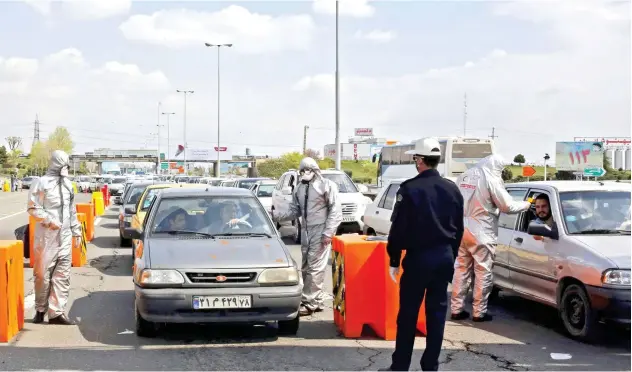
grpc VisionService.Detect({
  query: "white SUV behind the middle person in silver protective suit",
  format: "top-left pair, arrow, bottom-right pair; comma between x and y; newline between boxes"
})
272,169 -> 372,244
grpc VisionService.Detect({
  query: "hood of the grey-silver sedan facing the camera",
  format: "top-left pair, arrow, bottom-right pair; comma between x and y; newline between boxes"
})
148,237 -> 291,269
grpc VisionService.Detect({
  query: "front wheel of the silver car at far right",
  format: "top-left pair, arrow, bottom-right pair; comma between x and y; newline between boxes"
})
558,284 -> 599,342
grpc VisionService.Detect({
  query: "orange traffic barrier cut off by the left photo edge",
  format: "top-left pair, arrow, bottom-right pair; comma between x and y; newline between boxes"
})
0,240 -> 24,342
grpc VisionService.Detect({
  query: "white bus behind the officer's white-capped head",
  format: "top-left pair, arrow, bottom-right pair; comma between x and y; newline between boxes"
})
377,137 -> 496,187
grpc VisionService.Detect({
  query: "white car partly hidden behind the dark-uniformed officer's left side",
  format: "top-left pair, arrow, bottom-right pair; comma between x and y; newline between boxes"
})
362,178 -> 406,235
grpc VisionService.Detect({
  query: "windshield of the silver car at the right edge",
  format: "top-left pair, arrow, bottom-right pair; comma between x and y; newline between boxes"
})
560,191 -> 630,234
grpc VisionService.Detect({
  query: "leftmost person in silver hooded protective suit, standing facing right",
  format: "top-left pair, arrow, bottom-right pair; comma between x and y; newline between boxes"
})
28,150 -> 82,325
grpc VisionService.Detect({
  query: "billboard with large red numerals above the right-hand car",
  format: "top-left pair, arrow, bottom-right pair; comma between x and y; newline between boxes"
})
555,142 -> 604,172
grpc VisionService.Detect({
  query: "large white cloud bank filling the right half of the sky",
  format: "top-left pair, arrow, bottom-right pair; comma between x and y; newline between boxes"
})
293,1 -> 631,163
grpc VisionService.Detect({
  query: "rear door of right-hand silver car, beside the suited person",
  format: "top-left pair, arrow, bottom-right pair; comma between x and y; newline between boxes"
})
493,187 -> 528,289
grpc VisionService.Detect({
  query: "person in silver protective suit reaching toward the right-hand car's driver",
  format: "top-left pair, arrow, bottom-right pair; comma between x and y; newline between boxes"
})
451,154 -> 531,322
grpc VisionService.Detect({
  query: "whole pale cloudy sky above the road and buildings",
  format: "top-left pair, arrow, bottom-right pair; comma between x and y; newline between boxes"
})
0,0 -> 631,162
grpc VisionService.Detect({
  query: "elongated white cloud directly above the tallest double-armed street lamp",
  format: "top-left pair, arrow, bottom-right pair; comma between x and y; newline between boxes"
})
119,5 -> 315,54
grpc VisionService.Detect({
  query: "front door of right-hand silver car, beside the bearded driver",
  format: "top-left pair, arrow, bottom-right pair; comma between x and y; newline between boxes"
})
508,188 -> 559,304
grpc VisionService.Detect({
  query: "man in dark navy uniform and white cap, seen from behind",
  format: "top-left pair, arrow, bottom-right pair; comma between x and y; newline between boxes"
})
386,138 -> 463,371
